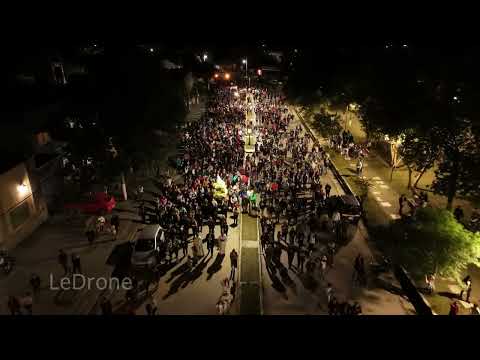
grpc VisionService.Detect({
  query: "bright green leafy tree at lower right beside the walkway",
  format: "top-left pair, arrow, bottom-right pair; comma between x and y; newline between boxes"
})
376,207 -> 480,279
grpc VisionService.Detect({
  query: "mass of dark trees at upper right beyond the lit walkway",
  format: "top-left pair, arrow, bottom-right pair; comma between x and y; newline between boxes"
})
286,43 -> 480,209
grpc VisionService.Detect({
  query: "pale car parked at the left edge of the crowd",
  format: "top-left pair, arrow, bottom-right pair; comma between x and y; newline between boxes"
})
131,225 -> 165,268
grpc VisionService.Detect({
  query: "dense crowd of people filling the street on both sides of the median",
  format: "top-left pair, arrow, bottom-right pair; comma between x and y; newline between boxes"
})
127,84 -> 364,313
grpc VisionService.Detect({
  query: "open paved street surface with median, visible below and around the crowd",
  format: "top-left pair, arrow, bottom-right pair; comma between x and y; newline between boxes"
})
0,90 -> 411,315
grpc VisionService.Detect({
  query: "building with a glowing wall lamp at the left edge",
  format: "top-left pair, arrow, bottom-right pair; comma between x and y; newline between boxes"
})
0,157 -> 48,249
